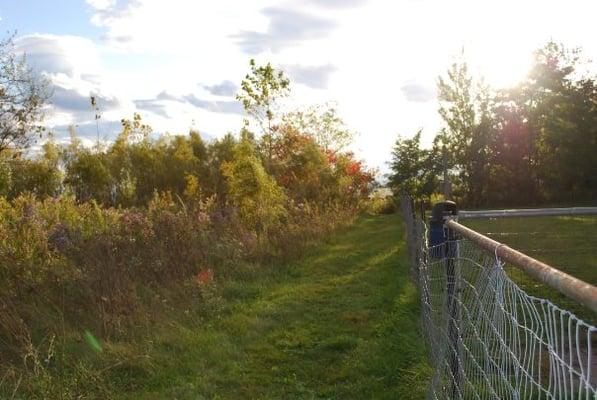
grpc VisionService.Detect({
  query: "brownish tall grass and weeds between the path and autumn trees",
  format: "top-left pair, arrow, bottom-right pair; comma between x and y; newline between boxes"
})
0,194 -> 356,398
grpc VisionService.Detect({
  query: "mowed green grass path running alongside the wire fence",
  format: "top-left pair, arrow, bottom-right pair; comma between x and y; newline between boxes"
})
121,215 -> 431,399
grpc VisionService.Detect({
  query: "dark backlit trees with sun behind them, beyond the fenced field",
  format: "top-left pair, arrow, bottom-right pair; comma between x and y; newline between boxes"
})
389,42 -> 597,207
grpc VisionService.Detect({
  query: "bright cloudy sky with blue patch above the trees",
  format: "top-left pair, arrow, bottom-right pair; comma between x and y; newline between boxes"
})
0,0 -> 597,172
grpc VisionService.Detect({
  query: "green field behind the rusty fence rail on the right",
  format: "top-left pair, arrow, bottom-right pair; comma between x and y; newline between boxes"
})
462,216 -> 597,323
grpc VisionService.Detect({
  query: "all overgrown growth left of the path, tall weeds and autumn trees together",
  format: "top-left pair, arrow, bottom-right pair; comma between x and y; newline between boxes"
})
0,53 -> 373,398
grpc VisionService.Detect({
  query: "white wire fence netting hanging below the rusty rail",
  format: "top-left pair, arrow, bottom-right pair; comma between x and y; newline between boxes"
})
407,211 -> 597,399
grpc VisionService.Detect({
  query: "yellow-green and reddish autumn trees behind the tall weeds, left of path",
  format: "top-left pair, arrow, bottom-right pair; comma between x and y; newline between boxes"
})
0,35 -> 373,223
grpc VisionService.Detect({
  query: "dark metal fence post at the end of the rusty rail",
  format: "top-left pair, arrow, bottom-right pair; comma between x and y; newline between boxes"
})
430,201 -> 462,399
